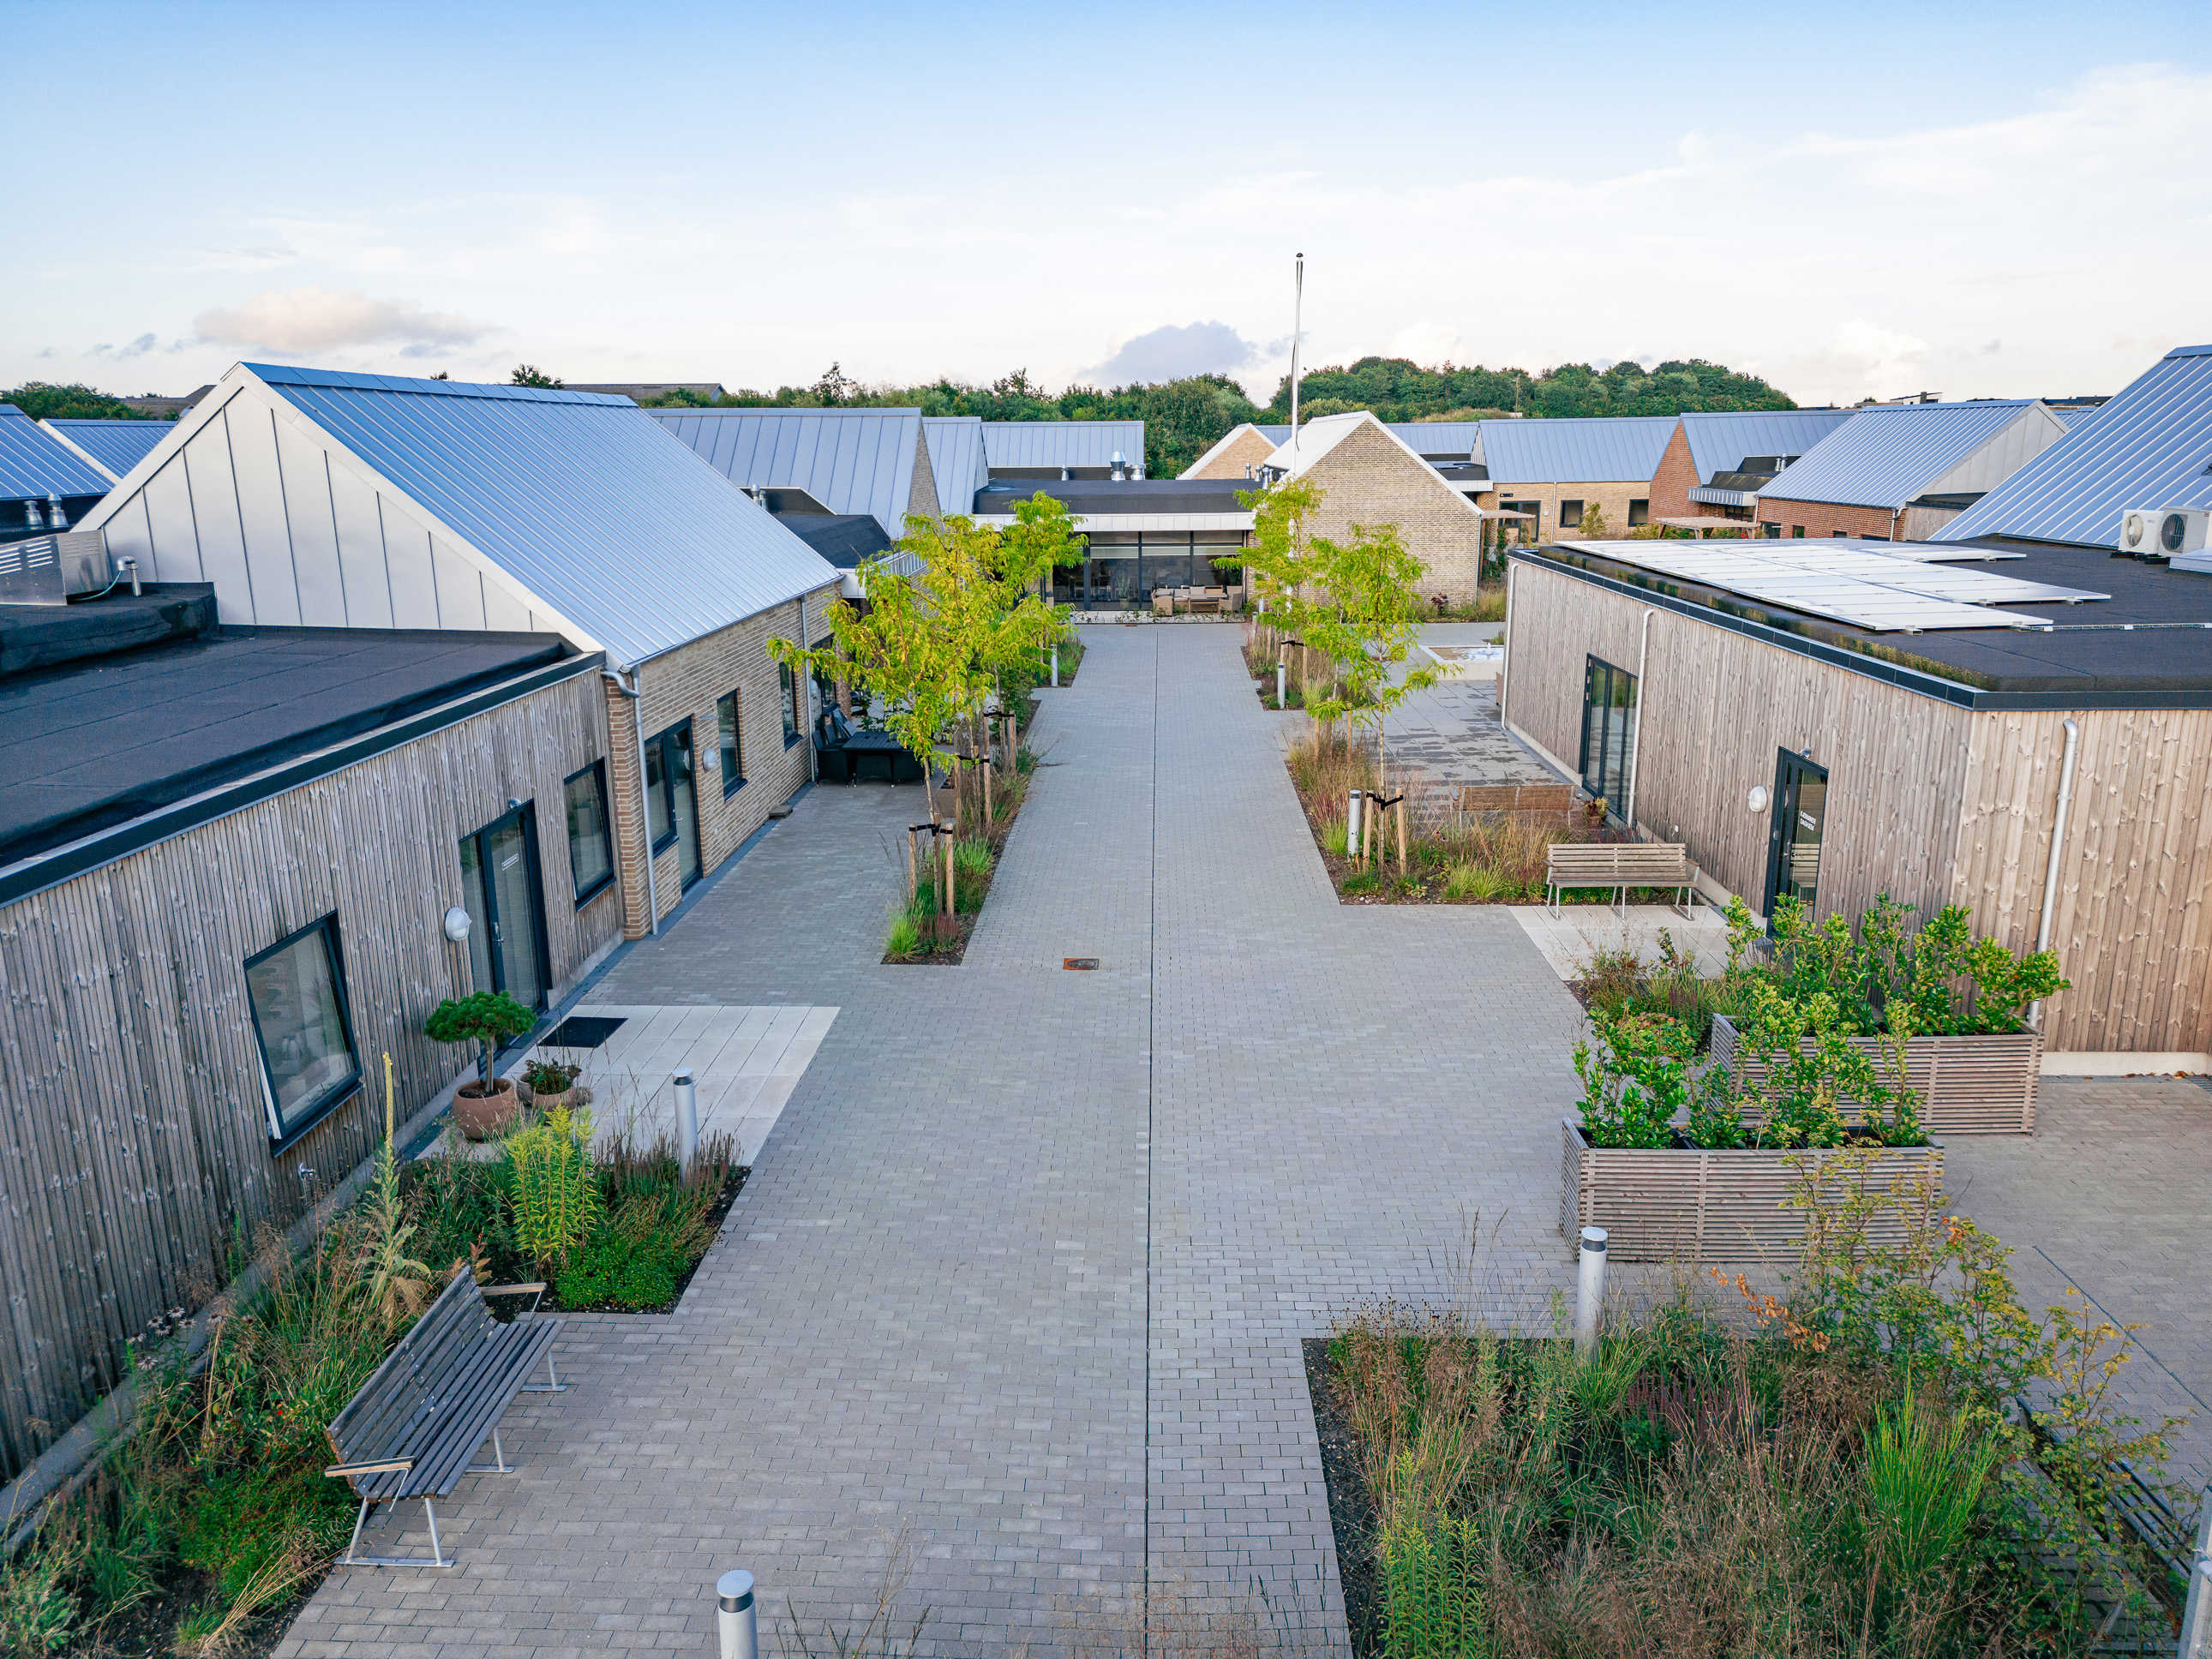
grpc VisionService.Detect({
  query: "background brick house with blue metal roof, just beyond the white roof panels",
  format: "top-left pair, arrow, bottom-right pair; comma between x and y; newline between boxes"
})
1754,398 -> 2066,542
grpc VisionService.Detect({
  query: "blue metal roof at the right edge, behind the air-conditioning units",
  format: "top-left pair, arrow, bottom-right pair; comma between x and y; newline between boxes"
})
1933,345 -> 2212,547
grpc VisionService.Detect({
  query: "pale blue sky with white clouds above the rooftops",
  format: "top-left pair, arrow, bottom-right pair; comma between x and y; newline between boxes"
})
0,0 -> 2212,404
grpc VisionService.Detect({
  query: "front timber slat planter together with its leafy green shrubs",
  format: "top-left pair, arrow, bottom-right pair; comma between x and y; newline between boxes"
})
1560,985 -> 1942,1263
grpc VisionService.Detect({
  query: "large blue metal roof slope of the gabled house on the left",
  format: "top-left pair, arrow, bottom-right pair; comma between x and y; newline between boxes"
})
243,362 -> 838,666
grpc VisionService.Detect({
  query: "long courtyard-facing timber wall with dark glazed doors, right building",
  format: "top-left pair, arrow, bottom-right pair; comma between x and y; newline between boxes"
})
1507,564 -> 1969,916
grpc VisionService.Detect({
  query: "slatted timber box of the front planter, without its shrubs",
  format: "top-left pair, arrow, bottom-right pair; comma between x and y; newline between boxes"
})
1560,1117 -> 1942,1266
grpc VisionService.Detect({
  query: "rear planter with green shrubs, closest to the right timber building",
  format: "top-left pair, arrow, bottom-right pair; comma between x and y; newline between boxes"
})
1712,894 -> 2066,1135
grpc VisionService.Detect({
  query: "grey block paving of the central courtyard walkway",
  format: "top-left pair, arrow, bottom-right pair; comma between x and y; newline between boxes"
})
279,628 -> 2212,1659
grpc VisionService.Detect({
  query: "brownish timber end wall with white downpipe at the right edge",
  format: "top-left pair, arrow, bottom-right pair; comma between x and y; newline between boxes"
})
1953,708 -> 2212,1053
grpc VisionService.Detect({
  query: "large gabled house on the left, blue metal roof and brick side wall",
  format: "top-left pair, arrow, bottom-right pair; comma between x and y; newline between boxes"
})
84,362 -> 841,937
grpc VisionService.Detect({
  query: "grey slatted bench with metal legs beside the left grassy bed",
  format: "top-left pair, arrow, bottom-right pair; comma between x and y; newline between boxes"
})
323,1267 -> 566,1566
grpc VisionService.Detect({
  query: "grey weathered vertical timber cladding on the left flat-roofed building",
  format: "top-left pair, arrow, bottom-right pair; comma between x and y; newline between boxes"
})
0,674 -> 621,1476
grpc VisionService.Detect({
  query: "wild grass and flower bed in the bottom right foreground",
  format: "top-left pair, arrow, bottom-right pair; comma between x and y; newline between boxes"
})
1316,1183 -> 2185,1659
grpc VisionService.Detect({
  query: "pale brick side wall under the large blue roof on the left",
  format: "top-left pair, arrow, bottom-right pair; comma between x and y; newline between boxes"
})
606,586 -> 836,937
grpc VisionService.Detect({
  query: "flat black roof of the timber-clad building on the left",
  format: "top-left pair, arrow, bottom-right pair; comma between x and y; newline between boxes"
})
0,628 -> 572,876
